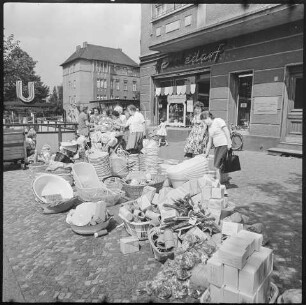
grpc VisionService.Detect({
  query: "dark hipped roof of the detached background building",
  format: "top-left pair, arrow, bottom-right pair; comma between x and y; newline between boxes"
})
60,44 -> 139,67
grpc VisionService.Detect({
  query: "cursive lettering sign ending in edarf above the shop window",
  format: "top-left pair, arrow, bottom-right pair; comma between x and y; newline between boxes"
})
155,43 -> 225,73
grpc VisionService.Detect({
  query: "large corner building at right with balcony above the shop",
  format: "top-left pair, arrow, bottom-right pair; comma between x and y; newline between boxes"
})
140,4 -> 304,149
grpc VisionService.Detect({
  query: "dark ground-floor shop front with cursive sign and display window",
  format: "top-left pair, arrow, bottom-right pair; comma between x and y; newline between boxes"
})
151,20 -> 303,149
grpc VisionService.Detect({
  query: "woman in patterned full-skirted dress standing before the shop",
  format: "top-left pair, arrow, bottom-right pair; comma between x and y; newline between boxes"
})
184,102 -> 207,158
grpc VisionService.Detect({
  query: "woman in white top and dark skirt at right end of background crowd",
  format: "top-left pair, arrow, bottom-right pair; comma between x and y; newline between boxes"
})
125,105 -> 145,153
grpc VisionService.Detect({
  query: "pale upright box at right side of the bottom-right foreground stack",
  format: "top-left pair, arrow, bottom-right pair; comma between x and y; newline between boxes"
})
239,252 -> 265,295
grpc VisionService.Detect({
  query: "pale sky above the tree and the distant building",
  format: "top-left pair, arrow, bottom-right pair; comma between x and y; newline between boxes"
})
3,3 -> 140,92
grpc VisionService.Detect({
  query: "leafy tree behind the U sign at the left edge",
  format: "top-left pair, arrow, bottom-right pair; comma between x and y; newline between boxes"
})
3,34 -> 49,102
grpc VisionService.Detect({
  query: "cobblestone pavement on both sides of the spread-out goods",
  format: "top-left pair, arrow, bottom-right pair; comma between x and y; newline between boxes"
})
3,143 -> 302,302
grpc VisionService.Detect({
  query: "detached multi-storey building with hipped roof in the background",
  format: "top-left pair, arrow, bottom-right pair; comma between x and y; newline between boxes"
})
61,42 -> 140,120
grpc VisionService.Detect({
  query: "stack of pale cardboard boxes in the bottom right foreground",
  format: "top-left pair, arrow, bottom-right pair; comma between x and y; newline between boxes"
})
207,230 -> 273,303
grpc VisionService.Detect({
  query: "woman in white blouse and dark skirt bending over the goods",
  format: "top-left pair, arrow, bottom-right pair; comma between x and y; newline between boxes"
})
200,111 -> 232,182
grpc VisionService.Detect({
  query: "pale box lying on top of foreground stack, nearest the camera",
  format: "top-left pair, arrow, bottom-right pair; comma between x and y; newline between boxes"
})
217,244 -> 247,268
